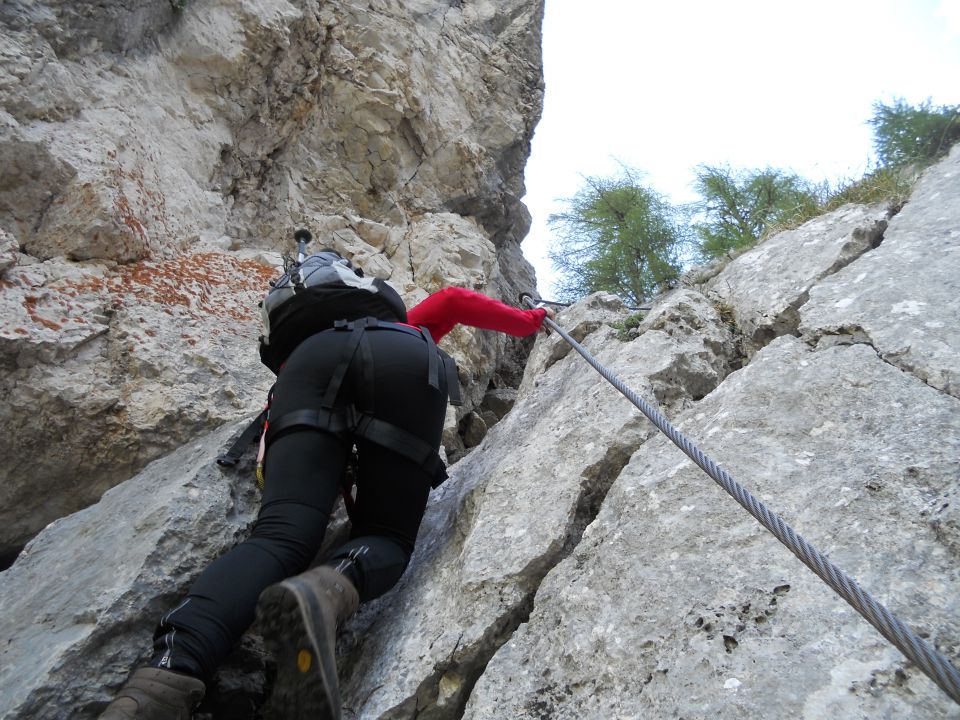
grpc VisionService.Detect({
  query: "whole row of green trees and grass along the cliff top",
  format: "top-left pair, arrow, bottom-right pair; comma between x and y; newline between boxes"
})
550,99 -> 960,305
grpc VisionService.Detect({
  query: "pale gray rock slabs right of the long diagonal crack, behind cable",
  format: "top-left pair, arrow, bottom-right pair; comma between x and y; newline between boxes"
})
458,147 -> 960,718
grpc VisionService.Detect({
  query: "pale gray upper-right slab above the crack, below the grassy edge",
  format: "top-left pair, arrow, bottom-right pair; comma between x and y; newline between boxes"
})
800,147 -> 960,397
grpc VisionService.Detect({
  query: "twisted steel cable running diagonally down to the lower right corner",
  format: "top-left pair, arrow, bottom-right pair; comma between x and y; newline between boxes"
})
520,293 -> 960,704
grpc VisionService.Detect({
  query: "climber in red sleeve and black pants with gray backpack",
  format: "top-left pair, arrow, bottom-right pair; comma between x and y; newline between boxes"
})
100,243 -> 553,720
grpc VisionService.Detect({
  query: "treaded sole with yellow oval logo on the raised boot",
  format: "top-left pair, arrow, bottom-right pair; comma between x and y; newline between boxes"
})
257,578 -> 340,720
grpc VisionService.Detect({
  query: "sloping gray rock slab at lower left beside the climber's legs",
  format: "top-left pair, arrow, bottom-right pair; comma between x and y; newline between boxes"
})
0,424 -> 259,720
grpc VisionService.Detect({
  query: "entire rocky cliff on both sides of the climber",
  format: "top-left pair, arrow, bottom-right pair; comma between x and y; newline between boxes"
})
0,0 -> 960,720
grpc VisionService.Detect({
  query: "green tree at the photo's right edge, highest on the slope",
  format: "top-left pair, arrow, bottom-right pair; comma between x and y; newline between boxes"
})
867,98 -> 960,168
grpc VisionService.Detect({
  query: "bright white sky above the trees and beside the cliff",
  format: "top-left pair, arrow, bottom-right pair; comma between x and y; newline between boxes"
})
522,0 -> 960,298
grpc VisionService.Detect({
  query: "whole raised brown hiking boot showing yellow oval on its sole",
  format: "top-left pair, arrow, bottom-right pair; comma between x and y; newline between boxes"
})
257,565 -> 360,720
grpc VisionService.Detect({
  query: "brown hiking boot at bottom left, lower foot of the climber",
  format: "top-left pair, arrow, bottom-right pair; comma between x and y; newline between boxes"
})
99,668 -> 206,720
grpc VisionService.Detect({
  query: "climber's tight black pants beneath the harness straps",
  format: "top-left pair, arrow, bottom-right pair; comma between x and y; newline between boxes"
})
152,329 -> 446,679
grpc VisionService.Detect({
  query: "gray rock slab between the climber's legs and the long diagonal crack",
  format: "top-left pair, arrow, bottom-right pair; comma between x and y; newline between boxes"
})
342,288 -> 732,718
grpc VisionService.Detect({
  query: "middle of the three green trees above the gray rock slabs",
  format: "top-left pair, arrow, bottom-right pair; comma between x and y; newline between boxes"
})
693,165 -> 821,260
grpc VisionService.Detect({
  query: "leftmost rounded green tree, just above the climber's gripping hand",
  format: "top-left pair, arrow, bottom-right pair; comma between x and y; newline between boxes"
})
549,168 -> 688,305
